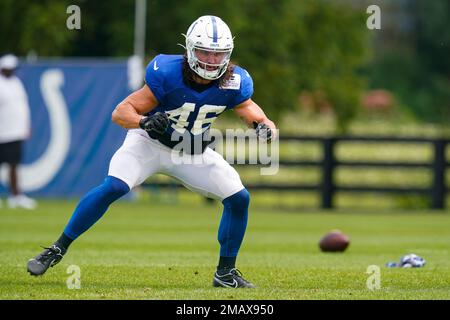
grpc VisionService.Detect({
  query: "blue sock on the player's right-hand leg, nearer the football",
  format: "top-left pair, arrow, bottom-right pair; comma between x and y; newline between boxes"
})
218,189 -> 250,260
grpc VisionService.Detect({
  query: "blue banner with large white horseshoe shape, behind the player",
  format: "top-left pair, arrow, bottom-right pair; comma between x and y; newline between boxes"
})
1,60 -> 130,197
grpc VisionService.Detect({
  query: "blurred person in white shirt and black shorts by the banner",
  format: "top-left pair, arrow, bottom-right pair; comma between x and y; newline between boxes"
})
0,54 -> 36,209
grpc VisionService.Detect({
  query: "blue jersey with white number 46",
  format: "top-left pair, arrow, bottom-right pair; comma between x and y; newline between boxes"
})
145,54 -> 253,153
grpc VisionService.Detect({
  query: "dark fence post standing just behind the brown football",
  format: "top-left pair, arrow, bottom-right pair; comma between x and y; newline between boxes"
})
322,138 -> 336,209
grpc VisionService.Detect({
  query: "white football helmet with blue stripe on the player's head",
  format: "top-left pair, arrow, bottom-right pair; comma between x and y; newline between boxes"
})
184,16 -> 234,80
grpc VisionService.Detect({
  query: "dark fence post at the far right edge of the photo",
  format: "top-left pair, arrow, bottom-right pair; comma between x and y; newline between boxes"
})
431,140 -> 447,209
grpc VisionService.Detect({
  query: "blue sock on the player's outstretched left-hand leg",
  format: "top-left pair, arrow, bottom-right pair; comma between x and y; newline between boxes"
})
64,176 -> 130,240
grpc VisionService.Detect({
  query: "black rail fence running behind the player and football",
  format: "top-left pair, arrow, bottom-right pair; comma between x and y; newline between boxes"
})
142,136 -> 450,209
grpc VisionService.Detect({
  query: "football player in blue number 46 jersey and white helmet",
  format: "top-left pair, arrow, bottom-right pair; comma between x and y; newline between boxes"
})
28,16 -> 276,288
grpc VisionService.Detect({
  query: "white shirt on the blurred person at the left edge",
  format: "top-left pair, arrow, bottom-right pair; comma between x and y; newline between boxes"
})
0,74 -> 31,143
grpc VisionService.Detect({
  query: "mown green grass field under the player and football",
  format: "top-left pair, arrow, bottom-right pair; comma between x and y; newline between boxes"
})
0,200 -> 450,300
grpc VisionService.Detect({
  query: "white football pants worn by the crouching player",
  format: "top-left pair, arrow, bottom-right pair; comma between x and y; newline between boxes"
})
108,129 -> 244,200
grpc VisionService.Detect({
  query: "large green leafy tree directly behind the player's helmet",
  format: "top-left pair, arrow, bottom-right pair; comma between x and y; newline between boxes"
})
147,0 -> 368,130
